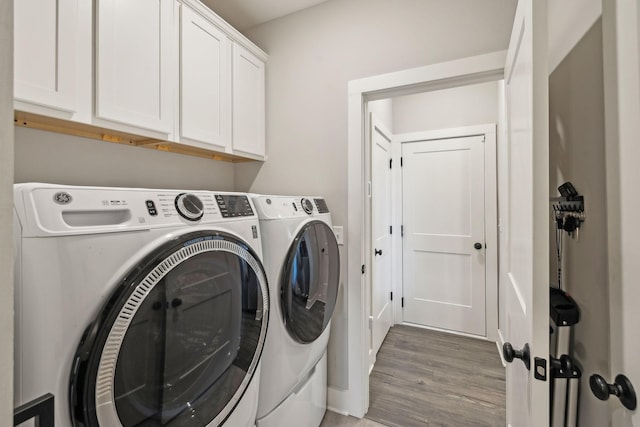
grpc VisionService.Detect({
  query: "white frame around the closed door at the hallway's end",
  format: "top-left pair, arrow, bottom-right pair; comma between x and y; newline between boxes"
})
391,123 -> 498,342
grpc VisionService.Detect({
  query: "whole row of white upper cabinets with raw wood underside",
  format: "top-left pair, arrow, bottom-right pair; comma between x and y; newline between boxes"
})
13,0 -> 267,160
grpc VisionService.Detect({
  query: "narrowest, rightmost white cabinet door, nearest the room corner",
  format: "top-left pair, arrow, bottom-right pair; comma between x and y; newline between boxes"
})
232,44 -> 265,158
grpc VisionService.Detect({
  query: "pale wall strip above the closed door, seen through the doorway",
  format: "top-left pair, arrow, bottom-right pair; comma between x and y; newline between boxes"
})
393,81 -> 498,134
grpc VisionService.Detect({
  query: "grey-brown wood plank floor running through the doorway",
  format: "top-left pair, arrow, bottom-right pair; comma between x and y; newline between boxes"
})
322,325 -> 505,427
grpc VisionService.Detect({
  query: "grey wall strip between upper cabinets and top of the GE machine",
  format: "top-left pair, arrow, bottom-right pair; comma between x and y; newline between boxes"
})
15,128 -> 234,190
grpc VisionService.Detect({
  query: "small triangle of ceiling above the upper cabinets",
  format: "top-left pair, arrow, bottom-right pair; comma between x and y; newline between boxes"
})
202,0 -> 327,31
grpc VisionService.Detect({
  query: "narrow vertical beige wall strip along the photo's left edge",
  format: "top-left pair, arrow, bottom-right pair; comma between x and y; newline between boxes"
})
0,0 -> 13,426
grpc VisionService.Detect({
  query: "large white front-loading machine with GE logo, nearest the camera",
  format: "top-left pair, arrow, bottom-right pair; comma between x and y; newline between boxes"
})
14,184 -> 269,427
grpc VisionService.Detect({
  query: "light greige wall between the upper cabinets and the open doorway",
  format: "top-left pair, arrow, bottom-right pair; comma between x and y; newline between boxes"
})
235,0 -> 516,396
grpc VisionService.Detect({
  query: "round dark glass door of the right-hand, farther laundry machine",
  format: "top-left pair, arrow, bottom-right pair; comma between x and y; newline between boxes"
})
281,221 -> 340,344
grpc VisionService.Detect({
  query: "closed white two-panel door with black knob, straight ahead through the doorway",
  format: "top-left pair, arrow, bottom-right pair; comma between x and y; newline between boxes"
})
402,135 -> 486,336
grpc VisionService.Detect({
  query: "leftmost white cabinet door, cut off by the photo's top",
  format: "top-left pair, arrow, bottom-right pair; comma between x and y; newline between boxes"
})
14,0 -> 77,113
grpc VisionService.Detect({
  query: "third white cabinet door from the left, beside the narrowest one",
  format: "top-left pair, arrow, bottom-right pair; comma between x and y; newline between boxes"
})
180,5 -> 231,149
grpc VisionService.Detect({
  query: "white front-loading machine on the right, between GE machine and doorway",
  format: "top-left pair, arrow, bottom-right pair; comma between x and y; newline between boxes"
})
253,195 -> 340,427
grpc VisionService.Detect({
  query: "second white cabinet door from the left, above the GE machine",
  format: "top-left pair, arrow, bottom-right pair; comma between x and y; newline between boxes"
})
96,0 -> 174,133
